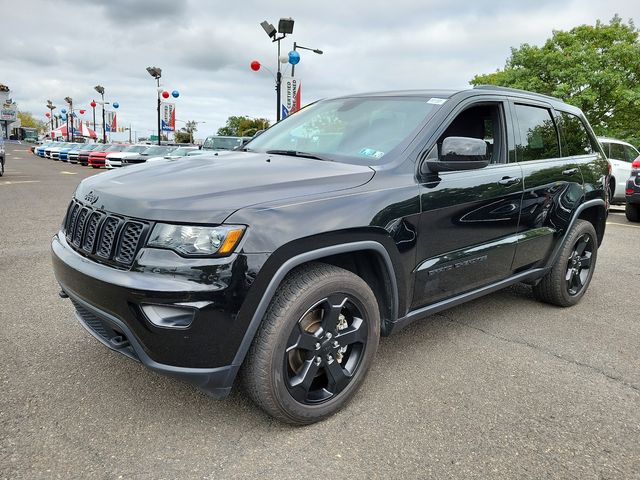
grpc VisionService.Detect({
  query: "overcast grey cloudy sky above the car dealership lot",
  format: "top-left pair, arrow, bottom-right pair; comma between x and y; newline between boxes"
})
0,0 -> 640,137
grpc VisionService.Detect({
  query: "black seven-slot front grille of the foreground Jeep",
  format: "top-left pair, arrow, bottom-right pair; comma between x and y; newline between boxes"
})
64,200 -> 149,266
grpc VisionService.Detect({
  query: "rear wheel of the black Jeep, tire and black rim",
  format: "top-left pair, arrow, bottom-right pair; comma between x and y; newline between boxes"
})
533,220 -> 598,307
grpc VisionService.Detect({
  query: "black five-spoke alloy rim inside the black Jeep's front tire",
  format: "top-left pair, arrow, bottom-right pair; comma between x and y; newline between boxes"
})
283,293 -> 367,404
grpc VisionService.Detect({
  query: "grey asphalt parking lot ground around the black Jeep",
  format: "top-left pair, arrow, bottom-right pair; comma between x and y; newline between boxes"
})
0,145 -> 640,479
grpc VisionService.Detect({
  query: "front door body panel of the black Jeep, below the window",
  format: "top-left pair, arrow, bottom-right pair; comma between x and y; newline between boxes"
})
412,164 -> 523,308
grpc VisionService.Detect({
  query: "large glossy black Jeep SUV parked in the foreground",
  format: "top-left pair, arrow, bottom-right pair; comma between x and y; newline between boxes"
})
52,87 -> 609,424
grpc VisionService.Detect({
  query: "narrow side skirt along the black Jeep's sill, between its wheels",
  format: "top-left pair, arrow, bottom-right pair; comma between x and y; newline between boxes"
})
389,267 -> 549,333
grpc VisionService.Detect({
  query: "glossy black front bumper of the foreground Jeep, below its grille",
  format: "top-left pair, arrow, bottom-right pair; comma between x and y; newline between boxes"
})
51,234 -> 264,397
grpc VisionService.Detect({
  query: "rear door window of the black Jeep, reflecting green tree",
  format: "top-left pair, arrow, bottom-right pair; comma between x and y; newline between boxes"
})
515,104 -> 560,162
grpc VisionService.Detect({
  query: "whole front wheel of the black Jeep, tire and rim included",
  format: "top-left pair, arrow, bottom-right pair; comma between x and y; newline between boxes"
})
243,263 -> 380,425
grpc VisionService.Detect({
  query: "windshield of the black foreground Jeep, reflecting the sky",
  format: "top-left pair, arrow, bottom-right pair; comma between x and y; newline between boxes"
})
246,97 -> 437,165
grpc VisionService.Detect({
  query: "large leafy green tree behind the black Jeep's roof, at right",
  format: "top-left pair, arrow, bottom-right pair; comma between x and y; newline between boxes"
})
470,15 -> 640,145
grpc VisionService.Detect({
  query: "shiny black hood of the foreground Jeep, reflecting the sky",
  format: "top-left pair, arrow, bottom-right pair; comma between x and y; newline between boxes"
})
75,152 -> 375,223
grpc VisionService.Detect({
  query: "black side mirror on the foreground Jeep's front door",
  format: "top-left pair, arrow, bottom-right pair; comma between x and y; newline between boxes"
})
423,137 -> 489,173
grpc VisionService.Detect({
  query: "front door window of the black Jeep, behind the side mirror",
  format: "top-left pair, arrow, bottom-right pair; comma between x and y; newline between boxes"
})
438,103 -> 501,164
